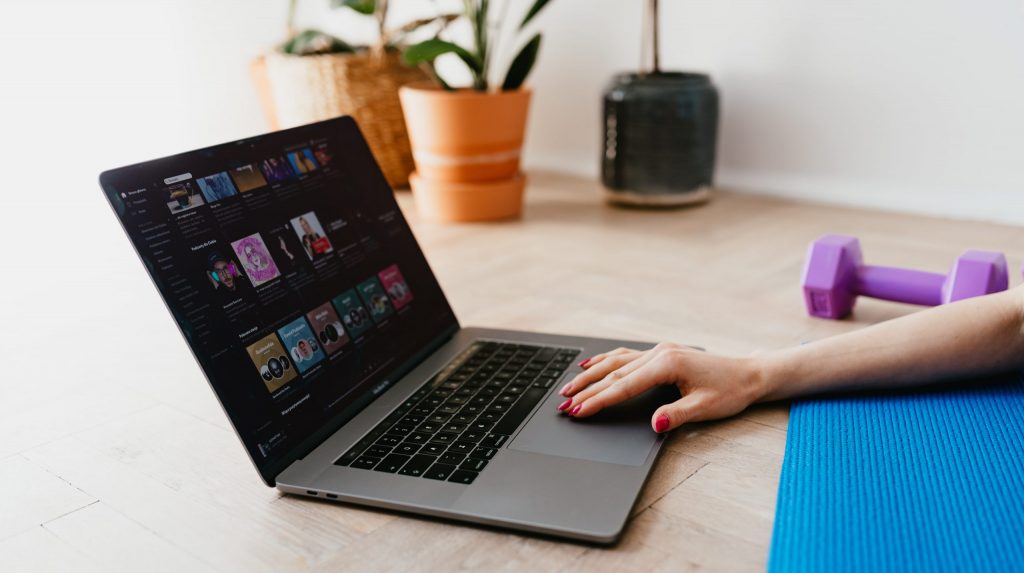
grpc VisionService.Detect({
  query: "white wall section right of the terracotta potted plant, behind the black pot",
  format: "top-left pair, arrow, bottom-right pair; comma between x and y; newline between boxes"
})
516,0 -> 1024,223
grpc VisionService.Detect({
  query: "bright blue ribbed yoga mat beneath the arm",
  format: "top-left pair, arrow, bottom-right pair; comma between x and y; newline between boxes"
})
768,376 -> 1024,572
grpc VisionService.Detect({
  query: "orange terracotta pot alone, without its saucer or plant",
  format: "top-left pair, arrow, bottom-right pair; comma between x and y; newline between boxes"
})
398,84 -> 530,183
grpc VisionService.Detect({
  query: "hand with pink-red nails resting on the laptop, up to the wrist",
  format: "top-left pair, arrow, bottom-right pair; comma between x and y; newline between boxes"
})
558,343 -> 765,432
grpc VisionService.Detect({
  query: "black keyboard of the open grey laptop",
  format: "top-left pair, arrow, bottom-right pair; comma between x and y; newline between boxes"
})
335,341 -> 580,484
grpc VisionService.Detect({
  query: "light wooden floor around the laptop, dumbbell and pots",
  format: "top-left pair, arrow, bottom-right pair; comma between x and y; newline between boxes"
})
0,174 -> 1024,573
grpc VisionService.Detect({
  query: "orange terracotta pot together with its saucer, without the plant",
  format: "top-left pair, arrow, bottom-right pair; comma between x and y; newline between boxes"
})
398,84 -> 530,222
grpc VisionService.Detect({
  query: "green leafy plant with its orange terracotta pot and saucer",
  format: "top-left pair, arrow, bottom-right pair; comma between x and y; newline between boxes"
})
399,0 -> 549,221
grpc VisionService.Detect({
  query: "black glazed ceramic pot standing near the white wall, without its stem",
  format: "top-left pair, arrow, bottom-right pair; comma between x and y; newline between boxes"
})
601,72 -> 719,207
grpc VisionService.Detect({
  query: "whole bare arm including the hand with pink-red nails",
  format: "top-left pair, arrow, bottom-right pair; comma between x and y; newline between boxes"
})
560,287 -> 1024,432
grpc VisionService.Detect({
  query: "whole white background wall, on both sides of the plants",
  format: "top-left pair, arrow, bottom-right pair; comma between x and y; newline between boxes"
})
0,0 -> 1024,223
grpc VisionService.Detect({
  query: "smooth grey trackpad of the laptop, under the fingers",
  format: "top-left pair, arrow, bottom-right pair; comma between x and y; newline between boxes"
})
509,386 -> 679,466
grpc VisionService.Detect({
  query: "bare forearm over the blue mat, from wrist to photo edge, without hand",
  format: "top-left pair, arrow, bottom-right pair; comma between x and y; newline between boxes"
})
753,287 -> 1024,401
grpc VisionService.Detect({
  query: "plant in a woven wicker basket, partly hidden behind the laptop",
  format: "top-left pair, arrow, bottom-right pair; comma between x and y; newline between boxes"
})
252,0 -> 457,188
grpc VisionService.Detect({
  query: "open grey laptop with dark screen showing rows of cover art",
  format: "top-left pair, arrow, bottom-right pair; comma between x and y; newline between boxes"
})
99,117 -> 679,543
